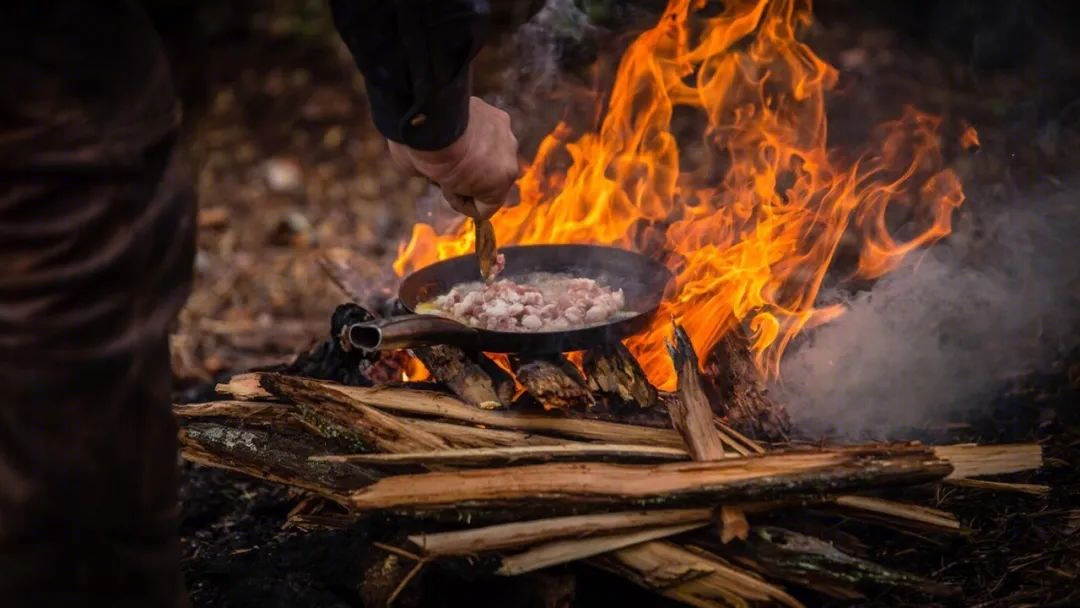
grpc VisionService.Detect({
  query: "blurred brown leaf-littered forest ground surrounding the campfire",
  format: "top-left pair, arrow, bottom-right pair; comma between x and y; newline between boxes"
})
172,1 -> 1080,608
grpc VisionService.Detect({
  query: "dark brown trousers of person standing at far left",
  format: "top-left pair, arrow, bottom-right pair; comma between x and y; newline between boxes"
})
0,0 -> 194,608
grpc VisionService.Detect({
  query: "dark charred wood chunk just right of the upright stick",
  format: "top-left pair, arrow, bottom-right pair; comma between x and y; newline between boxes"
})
703,329 -> 791,441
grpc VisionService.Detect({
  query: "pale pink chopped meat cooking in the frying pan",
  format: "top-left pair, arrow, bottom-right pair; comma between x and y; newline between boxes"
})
422,272 -> 625,332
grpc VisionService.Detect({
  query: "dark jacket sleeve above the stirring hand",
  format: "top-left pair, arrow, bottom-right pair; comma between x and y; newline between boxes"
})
330,0 -> 489,150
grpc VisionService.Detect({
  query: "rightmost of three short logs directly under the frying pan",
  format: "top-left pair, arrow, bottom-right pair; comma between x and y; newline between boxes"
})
582,341 -> 658,409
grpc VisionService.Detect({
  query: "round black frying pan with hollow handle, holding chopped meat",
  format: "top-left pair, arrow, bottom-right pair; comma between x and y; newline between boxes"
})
342,245 -> 672,354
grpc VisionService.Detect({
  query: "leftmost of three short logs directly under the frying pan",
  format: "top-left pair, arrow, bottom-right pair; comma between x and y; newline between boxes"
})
413,344 -> 514,409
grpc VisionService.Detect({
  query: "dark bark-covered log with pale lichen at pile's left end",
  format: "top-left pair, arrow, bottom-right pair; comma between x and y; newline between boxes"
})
180,422 -> 377,504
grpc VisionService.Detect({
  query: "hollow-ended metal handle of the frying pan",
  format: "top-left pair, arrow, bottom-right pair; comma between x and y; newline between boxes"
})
342,314 -> 477,351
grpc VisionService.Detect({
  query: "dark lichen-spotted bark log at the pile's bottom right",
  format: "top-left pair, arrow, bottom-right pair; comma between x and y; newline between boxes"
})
740,526 -> 958,598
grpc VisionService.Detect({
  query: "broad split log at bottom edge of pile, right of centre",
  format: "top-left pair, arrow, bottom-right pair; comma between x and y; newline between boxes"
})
589,541 -> 802,608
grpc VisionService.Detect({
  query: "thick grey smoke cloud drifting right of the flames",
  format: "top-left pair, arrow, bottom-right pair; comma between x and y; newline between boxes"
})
775,187 -> 1080,440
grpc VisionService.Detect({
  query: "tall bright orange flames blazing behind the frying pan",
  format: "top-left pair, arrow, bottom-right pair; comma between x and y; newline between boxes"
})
395,0 -> 973,388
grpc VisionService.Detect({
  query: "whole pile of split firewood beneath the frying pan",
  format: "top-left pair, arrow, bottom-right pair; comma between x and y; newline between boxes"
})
174,327 -> 1042,608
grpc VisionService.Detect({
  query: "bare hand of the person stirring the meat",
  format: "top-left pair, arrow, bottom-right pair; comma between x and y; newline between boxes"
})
389,97 -> 518,219
